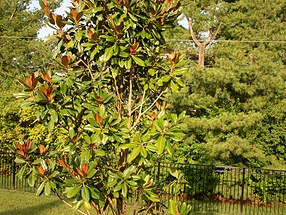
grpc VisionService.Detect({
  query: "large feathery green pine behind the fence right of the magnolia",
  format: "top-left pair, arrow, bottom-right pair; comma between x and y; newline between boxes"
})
170,0 -> 286,167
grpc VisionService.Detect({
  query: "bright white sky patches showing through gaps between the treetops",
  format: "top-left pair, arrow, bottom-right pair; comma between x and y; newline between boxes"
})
31,0 -> 188,39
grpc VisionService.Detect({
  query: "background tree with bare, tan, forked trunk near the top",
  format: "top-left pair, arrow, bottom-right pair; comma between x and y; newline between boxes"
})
182,0 -> 225,67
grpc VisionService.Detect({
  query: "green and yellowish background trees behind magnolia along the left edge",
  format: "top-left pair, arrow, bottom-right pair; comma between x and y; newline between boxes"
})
0,0 -> 61,150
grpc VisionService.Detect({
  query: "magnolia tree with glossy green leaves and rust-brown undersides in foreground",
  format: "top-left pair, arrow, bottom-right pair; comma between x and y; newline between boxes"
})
15,0 -> 185,215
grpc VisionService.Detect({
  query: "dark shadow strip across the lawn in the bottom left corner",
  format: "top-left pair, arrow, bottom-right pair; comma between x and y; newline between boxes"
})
0,200 -> 62,215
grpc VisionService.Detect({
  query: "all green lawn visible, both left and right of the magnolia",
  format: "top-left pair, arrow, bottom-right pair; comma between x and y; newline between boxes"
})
0,189 -> 286,215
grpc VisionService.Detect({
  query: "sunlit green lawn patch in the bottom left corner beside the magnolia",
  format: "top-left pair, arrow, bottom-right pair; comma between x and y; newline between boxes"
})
0,189 -> 78,215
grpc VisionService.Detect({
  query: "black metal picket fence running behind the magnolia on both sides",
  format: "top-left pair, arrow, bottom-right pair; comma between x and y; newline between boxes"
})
0,153 -> 286,215
